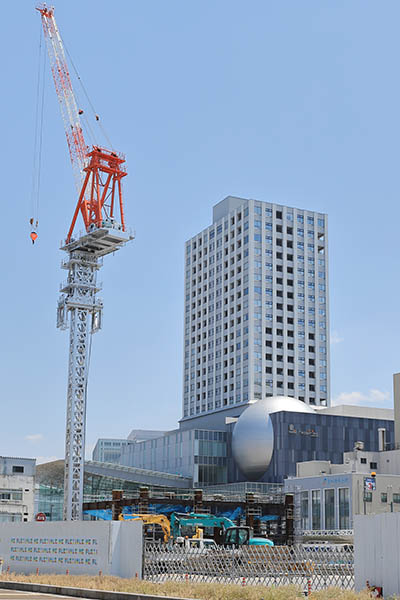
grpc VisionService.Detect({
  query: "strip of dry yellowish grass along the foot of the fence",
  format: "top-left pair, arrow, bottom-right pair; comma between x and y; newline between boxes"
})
0,573 -> 371,600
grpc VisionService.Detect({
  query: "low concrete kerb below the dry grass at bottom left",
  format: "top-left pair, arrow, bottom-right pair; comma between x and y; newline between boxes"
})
0,581 -> 190,600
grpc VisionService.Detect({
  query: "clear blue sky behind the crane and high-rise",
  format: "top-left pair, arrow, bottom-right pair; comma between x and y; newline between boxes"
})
0,0 -> 400,459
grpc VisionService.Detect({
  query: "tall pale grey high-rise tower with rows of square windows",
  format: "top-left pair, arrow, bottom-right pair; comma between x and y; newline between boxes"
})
183,196 -> 329,421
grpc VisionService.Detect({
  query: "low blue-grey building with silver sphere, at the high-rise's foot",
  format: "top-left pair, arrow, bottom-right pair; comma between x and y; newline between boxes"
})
121,396 -> 394,487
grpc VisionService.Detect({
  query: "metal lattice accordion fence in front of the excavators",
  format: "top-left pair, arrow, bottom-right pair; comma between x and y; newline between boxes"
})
143,540 -> 354,590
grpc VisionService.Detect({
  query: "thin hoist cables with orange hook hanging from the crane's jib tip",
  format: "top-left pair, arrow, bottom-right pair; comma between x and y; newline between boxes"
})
29,22 -> 46,244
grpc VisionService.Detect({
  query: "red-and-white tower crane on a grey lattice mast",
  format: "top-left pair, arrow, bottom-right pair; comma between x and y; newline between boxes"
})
37,4 -> 133,520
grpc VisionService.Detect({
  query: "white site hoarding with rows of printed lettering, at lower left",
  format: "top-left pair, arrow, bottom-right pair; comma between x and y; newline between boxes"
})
0,521 -> 143,577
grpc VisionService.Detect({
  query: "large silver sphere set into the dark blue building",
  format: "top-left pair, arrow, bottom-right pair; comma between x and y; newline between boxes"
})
232,396 -> 315,481
